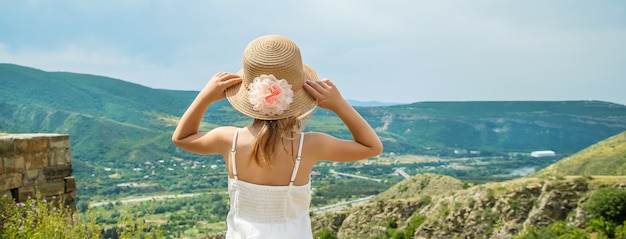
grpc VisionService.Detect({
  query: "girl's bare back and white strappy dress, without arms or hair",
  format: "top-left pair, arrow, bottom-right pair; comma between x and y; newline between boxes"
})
226,129 -> 312,238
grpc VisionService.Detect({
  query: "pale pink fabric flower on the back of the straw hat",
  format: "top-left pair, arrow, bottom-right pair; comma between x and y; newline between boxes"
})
248,75 -> 293,116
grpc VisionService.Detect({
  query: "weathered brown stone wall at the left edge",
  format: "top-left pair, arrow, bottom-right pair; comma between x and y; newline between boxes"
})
0,134 -> 76,205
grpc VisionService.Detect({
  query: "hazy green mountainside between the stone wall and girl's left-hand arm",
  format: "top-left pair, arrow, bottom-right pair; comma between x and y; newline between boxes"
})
0,64 -> 201,162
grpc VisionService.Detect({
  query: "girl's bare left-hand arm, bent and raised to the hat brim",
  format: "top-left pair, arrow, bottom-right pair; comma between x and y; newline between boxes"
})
172,72 -> 242,154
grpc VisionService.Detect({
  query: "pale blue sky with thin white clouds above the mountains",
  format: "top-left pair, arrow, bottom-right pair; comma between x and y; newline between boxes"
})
0,0 -> 626,105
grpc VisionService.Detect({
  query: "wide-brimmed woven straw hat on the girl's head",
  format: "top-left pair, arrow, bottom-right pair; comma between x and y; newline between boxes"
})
226,35 -> 319,120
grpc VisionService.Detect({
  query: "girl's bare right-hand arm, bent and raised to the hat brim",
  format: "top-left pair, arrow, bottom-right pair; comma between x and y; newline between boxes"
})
304,79 -> 383,162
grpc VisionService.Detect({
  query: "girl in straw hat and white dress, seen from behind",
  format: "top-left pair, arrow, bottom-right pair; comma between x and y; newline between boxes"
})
172,35 -> 383,238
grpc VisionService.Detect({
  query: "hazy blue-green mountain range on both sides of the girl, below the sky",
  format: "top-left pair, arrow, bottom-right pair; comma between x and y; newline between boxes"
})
0,64 -> 626,162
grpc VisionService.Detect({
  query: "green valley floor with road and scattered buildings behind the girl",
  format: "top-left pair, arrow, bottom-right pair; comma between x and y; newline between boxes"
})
75,150 -> 562,236
